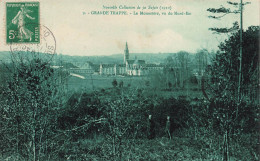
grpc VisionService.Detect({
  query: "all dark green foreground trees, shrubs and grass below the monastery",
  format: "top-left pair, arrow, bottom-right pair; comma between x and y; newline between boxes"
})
0,27 -> 259,161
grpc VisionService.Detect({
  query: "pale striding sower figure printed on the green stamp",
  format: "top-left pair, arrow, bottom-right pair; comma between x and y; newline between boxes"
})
12,5 -> 35,41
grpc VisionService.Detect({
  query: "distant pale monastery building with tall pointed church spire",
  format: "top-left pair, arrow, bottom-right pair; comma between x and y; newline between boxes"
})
99,43 -> 164,76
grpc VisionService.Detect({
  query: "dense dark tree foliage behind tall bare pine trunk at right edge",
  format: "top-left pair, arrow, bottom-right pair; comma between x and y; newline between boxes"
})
211,26 -> 259,98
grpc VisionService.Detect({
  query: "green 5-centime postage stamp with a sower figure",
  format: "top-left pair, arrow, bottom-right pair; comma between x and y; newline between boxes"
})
6,2 -> 40,43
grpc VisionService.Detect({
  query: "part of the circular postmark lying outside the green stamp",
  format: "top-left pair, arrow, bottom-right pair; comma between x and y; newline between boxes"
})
10,23 -> 56,63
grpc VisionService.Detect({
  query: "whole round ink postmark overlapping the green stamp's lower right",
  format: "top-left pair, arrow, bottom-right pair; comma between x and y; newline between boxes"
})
10,23 -> 56,63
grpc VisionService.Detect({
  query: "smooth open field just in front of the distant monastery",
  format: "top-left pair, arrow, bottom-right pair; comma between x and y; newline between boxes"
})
68,75 -> 203,98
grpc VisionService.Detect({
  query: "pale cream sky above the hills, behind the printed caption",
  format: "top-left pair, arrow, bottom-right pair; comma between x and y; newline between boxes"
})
0,0 -> 260,56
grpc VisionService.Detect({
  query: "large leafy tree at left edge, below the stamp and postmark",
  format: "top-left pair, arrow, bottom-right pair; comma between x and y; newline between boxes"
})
0,59 -> 65,160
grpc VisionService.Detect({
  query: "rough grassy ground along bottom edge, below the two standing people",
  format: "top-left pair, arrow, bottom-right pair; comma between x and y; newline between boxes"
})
51,131 -> 258,161
